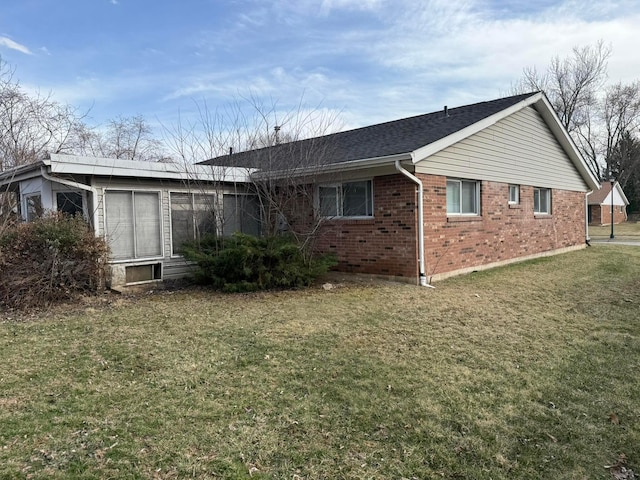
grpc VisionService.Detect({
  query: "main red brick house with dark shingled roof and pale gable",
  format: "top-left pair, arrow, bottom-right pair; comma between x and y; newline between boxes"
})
203,92 -> 599,285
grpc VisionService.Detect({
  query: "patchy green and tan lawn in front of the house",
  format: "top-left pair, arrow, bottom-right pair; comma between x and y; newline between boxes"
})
0,246 -> 640,480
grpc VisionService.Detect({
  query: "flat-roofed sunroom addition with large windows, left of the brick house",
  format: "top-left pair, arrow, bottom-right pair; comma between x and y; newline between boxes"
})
0,155 -> 255,287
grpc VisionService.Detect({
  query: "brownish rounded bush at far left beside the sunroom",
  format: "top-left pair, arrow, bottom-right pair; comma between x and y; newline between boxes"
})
0,213 -> 108,308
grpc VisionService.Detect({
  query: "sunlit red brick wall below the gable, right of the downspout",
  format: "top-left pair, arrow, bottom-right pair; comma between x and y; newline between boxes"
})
420,175 -> 585,277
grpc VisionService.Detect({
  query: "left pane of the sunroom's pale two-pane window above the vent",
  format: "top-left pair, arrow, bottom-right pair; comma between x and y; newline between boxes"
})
105,192 -> 135,260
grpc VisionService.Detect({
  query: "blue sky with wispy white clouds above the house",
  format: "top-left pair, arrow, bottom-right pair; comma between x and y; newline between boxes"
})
0,0 -> 640,139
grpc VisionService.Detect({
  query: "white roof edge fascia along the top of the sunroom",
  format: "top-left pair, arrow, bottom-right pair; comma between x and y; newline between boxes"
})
47,155 -> 252,182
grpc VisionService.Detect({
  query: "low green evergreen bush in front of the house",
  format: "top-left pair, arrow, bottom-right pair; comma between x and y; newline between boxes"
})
183,233 -> 335,292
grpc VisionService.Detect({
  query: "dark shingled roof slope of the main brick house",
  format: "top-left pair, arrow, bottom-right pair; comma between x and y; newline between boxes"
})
201,92 -> 538,171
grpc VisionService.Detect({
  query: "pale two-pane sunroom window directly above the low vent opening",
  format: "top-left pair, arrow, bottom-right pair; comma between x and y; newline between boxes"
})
105,190 -> 162,260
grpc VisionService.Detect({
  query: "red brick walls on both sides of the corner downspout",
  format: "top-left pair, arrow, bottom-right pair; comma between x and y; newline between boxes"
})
317,175 -> 585,280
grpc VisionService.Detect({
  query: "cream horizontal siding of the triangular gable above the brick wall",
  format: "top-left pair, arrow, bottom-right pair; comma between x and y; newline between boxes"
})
416,107 -> 588,191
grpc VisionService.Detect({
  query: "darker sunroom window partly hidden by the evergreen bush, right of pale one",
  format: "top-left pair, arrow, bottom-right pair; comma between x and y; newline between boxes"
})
170,192 -> 217,255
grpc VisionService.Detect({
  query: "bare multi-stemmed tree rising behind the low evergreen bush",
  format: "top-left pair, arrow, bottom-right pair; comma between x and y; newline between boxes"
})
165,95 -> 344,260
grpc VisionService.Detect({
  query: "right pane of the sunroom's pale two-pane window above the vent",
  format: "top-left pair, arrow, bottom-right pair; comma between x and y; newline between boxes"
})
133,192 -> 162,257
